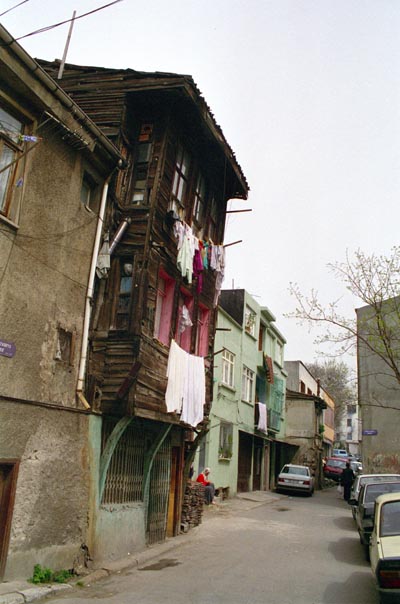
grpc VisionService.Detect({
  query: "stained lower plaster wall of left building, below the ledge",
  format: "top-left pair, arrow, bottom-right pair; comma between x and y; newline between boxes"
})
0,398 -> 89,580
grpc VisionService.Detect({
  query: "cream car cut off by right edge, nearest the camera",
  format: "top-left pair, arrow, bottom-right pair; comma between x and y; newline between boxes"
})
369,493 -> 400,604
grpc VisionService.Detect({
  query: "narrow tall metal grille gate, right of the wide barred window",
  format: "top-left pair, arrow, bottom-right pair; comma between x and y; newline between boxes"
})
147,437 -> 171,544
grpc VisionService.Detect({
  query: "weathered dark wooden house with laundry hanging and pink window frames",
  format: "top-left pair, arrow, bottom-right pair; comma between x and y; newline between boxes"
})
41,61 -> 248,558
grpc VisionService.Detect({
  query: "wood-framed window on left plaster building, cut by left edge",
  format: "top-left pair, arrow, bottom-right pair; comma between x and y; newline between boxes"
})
0,107 -> 24,216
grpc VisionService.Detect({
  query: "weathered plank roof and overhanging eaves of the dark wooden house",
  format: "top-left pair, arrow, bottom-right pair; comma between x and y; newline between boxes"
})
37,59 -> 249,199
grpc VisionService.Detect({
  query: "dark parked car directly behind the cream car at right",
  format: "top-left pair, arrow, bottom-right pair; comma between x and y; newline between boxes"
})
353,480 -> 400,560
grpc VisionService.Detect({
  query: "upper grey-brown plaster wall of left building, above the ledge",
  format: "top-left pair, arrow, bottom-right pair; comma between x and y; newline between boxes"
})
0,126 -> 101,405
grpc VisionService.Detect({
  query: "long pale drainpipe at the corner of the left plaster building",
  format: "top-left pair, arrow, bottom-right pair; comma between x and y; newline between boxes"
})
76,177 -> 110,409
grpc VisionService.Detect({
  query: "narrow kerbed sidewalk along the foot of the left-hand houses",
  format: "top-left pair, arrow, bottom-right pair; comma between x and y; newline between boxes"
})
0,491 -> 281,604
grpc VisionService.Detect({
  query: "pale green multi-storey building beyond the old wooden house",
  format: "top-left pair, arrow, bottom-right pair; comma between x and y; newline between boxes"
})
196,289 -> 286,495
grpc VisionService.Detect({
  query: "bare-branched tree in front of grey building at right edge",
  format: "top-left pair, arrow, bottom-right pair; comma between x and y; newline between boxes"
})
286,246 -> 400,410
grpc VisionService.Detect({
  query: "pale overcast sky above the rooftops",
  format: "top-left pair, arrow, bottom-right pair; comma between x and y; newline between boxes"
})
0,0 -> 400,362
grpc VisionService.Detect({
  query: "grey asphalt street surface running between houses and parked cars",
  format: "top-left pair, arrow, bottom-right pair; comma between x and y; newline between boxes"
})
46,488 -> 378,604
